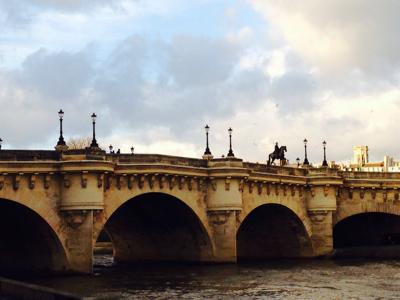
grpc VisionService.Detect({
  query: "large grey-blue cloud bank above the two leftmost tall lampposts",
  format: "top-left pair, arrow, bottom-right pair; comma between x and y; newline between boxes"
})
0,35 -> 268,150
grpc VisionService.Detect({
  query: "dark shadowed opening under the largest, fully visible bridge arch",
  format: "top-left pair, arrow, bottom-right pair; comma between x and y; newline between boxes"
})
103,193 -> 213,262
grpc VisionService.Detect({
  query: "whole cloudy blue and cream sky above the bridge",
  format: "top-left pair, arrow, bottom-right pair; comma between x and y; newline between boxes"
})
0,0 -> 400,163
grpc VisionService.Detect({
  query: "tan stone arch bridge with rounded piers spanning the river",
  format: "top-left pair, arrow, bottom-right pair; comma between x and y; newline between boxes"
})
0,148 -> 400,273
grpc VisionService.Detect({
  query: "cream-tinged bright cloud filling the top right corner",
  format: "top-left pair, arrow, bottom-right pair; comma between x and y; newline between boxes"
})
251,0 -> 400,80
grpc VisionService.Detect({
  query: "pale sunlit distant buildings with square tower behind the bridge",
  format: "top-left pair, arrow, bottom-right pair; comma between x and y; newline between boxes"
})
338,146 -> 400,172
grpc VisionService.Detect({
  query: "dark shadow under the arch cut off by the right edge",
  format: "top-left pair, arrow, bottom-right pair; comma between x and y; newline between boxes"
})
333,212 -> 400,250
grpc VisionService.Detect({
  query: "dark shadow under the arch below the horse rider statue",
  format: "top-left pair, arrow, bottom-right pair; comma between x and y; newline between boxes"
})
236,203 -> 313,261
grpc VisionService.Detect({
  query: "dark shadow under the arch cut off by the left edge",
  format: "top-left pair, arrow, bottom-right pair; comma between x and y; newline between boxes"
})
0,199 -> 68,275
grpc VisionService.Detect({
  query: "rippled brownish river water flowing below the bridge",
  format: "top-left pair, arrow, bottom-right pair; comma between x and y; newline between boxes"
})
21,255 -> 400,299
